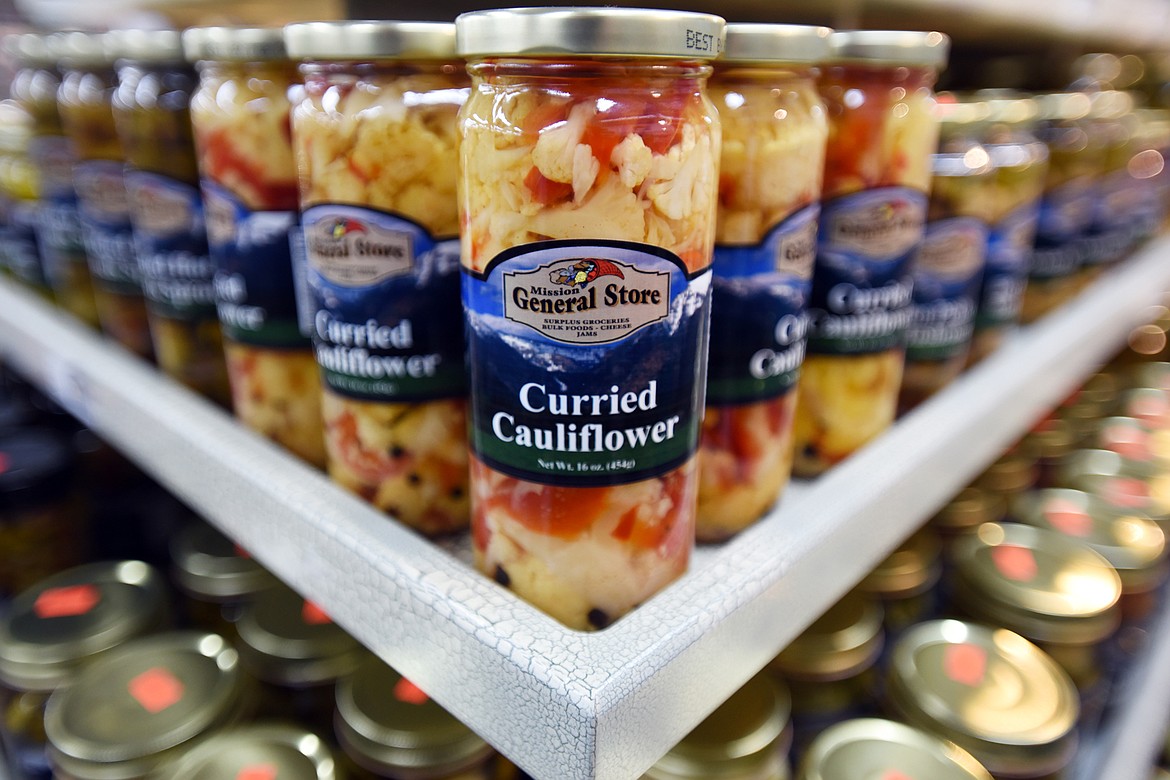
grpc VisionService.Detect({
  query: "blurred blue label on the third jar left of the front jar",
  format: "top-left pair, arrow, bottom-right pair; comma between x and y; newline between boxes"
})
125,170 -> 215,319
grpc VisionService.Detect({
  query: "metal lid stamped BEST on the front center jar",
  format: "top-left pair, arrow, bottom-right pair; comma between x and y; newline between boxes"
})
455,7 -> 725,60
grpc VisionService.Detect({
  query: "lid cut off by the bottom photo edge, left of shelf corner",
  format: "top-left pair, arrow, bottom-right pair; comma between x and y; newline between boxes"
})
151,723 -> 342,780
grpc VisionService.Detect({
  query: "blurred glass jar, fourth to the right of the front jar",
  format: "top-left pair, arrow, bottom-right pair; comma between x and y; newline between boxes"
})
969,90 -> 1048,364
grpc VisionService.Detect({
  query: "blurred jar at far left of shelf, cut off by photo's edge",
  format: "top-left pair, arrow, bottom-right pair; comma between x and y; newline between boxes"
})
0,95 -> 53,294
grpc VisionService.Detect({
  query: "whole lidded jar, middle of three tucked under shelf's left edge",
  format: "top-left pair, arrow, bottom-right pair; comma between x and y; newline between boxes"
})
235,584 -> 362,733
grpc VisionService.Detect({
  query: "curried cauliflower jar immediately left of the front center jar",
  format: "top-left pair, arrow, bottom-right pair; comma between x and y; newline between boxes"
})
285,22 -> 469,534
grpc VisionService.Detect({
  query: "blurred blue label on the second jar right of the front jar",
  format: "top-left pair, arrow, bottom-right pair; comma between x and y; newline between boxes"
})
808,187 -> 927,354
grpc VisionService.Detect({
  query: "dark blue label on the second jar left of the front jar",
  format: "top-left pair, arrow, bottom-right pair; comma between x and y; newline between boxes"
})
202,179 -> 308,347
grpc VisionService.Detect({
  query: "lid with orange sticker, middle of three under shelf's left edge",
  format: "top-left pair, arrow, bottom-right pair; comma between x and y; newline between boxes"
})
235,585 -> 363,686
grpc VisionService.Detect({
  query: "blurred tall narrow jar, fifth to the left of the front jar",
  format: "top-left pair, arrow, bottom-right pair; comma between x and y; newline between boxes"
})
6,33 -> 98,327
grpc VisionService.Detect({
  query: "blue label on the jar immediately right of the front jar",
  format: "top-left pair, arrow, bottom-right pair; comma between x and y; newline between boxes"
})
707,205 -> 820,405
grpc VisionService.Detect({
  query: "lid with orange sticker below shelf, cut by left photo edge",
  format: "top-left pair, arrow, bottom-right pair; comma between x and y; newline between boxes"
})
0,560 -> 167,691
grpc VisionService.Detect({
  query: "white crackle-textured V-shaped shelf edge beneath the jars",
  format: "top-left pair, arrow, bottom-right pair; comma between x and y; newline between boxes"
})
0,239 -> 1170,780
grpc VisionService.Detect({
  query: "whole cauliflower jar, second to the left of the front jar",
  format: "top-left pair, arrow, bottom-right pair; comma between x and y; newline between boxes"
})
183,27 -> 325,468
